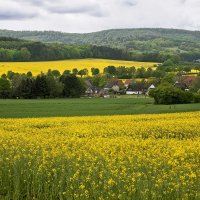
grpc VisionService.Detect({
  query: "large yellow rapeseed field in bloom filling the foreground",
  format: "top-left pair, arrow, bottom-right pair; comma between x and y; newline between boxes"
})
0,112 -> 200,200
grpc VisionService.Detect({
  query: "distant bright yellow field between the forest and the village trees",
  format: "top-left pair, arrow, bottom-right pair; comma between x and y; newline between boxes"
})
0,59 -> 157,75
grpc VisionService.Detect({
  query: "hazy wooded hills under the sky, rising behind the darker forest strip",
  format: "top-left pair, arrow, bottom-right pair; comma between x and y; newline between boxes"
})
0,29 -> 200,63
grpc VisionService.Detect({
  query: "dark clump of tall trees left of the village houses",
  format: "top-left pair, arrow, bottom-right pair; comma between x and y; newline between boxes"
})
0,70 -> 85,99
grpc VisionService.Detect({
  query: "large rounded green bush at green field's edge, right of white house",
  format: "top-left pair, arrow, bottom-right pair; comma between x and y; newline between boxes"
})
149,84 -> 193,104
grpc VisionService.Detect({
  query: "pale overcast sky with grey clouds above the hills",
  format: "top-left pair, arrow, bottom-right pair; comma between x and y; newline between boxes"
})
0,0 -> 200,32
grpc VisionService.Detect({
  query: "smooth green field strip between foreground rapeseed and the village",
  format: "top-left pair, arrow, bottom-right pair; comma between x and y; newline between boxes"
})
0,98 -> 200,118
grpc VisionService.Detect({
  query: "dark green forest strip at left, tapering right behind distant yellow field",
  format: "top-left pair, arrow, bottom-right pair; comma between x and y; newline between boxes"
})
0,37 -> 131,61
